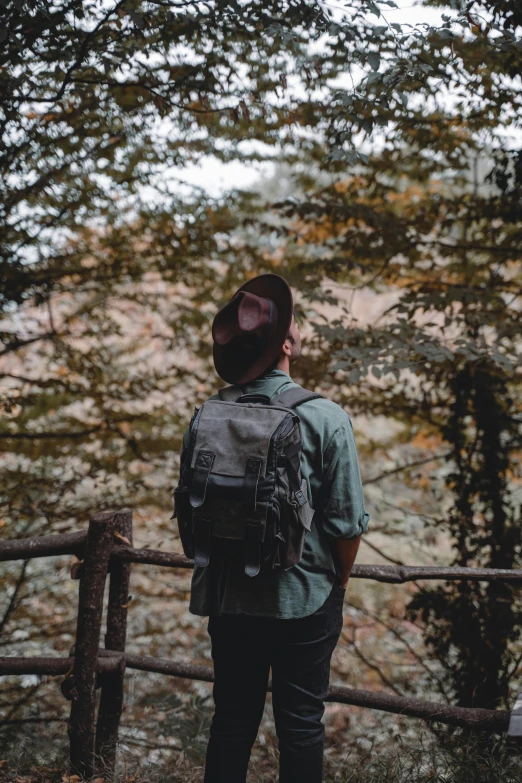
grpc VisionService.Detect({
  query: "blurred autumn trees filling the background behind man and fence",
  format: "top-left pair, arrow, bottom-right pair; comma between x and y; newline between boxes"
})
0,0 -> 522,776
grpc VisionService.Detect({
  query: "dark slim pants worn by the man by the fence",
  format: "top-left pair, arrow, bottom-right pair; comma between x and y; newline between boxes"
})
205,583 -> 345,783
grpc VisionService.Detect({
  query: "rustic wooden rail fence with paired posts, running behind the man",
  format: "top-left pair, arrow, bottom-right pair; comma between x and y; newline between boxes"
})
0,509 -> 522,777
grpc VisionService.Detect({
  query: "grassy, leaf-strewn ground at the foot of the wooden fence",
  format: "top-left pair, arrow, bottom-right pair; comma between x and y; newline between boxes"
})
0,710 -> 522,783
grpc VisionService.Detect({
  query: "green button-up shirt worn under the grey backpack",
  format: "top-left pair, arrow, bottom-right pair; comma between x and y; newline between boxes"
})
182,370 -> 370,618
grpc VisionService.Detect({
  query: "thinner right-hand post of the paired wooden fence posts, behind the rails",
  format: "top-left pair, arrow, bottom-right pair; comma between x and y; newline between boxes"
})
95,509 -> 132,773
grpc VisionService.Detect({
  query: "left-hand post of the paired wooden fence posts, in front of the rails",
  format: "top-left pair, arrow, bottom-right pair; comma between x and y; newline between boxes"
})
67,511 -> 117,777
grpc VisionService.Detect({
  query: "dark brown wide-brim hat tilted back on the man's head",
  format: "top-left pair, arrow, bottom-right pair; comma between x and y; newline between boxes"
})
212,274 -> 294,384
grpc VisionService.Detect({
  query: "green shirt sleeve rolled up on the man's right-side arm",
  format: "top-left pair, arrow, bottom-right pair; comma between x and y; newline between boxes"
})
322,414 -> 370,539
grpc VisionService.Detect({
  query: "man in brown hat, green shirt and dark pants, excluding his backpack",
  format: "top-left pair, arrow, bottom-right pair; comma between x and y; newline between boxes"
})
177,274 -> 369,783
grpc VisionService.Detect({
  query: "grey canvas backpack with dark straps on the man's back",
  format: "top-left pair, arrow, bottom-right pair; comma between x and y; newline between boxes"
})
172,386 -> 323,576
